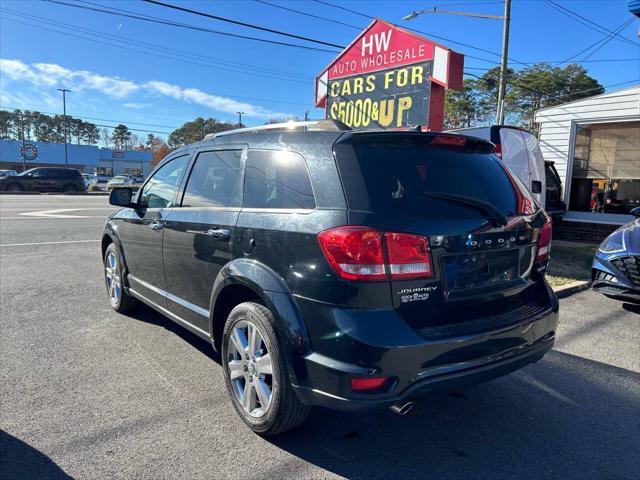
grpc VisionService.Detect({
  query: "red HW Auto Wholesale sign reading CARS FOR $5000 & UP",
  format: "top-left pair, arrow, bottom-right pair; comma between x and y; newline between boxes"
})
315,19 -> 464,130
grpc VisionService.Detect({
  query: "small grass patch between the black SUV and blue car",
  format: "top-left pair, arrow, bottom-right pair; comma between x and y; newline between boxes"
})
547,245 -> 598,287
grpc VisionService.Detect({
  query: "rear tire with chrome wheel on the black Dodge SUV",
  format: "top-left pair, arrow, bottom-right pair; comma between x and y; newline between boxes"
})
222,302 -> 310,436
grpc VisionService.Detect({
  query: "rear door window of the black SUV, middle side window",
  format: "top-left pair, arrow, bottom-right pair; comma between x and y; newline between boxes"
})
182,150 -> 242,207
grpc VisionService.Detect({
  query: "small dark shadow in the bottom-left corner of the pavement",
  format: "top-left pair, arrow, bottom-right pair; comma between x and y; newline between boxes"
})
0,430 -> 72,480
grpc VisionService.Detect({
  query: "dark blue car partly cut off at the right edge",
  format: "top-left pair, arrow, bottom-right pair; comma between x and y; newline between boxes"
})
591,207 -> 640,304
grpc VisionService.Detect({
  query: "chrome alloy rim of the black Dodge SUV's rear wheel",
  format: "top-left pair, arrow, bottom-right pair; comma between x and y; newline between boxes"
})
227,320 -> 276,418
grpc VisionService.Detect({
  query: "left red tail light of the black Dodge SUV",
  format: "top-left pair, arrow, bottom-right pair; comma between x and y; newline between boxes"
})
318,227 -> 433,280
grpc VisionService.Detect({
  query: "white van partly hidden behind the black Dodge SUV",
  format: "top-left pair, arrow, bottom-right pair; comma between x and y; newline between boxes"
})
451,125 -> 547,208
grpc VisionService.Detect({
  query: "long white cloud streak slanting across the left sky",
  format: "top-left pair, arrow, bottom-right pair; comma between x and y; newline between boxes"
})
0,59 -> 290,118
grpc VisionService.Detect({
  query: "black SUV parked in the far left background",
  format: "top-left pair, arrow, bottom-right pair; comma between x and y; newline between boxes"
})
0,167 -> 86,192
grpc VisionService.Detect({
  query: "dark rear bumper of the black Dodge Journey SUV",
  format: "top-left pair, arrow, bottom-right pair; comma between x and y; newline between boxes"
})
294,286 -> 558,411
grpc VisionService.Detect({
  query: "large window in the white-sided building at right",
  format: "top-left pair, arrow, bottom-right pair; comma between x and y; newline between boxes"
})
569,122 -> 640,214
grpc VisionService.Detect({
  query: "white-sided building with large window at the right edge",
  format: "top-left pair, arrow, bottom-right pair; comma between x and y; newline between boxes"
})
535,85 -> 640,241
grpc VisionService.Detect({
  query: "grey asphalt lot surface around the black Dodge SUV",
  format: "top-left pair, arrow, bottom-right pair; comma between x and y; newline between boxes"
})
0,195 -> 640,479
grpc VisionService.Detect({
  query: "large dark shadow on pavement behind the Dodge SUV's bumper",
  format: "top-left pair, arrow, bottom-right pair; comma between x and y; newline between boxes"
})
263,351 -> 640,479
